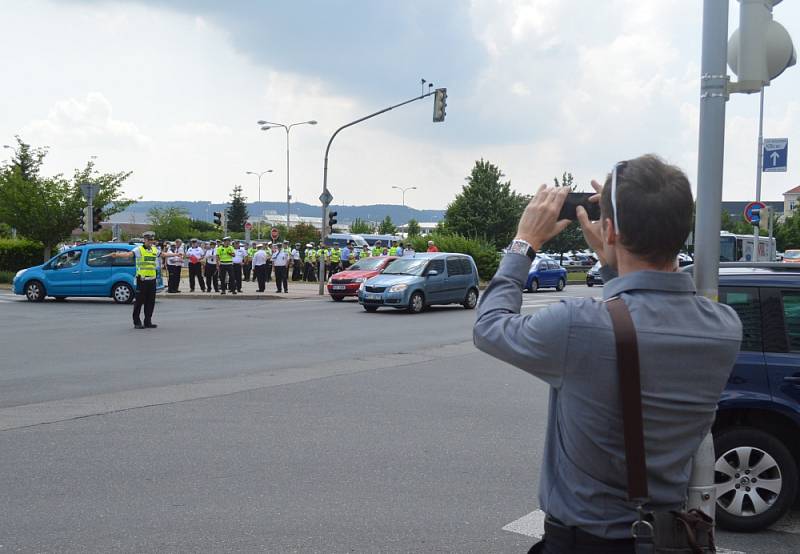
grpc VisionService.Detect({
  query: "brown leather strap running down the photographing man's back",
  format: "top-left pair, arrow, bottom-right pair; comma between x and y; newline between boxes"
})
606,296 -> 648,500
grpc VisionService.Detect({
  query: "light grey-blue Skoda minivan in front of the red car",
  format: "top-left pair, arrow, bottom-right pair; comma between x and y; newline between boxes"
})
358,253 -> 478,314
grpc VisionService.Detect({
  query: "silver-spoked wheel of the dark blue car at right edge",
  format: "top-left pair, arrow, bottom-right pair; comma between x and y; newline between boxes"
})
714,427 -> 797,531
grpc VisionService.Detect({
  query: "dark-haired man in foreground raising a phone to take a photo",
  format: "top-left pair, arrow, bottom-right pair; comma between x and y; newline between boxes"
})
474,155 -> 742,553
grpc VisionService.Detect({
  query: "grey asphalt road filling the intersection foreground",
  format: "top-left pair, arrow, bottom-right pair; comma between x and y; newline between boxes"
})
0,286 -> 800,553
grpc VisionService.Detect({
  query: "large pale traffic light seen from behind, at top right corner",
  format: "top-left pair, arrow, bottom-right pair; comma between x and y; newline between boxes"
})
728,0 -> 797,94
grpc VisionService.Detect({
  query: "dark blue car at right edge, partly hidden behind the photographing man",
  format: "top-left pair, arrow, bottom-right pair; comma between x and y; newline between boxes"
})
686,263 -> 800,531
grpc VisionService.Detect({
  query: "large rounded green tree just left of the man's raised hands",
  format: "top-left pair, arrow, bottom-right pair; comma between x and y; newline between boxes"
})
442,159 -> 529,248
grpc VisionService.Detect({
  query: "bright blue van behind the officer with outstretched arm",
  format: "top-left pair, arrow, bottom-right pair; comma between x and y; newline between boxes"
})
11,243 -> 164,304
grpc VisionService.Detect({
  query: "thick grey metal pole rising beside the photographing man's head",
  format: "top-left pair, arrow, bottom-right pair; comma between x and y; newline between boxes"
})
694,0 -> 729,301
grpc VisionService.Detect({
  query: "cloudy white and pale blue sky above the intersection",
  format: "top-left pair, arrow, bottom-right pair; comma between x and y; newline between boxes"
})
0,0 -> 800,208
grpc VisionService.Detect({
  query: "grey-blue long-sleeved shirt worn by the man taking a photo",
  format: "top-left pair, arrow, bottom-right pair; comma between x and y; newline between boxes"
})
474,254 -> 742,538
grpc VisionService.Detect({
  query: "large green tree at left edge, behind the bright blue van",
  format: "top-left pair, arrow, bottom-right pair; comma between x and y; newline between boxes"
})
0,137 -> 134,259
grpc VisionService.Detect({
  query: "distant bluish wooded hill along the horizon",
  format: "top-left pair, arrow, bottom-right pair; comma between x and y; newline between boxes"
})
111,200 -> 444,225
